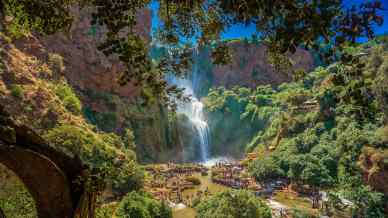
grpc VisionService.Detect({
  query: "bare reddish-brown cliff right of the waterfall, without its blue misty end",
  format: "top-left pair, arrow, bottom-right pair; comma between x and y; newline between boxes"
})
213,41 -> 314,88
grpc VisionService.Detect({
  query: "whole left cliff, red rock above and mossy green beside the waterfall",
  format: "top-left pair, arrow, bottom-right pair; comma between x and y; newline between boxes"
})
2,8 -> 185,161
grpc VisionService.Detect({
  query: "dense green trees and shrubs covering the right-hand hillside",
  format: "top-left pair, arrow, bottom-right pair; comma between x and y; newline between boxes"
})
205,37 -> 388,217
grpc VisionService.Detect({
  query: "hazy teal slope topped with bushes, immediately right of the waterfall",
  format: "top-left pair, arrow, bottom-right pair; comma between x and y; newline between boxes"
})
202,86 -> 278,154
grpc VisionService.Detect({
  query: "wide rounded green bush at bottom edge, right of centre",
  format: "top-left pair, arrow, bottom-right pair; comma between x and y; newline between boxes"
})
196,190 -> 272,218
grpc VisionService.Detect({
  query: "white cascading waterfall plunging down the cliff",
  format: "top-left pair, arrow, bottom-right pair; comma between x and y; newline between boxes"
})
167,73 -> 210,162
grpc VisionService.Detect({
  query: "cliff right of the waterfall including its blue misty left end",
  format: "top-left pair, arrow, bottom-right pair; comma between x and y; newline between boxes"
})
193,40 -> 315,96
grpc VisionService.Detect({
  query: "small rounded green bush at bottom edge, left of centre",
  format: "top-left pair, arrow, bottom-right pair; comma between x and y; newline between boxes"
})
115,192 -> 172,218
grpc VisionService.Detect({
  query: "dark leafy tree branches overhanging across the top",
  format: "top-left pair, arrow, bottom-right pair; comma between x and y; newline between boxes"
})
0,0 -> 383,102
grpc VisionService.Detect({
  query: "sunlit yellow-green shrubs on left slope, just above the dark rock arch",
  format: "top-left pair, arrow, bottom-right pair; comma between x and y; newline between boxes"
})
44,124 -> 141,187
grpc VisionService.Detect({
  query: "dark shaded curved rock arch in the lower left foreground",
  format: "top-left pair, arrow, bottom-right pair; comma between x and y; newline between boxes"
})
0,107 -> 86,218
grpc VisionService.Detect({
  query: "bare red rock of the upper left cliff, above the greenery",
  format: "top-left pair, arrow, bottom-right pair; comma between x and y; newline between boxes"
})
13,8 -> 151,97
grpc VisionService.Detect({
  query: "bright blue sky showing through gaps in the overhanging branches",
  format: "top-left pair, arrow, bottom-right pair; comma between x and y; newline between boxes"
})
151,0 -> 388,39
